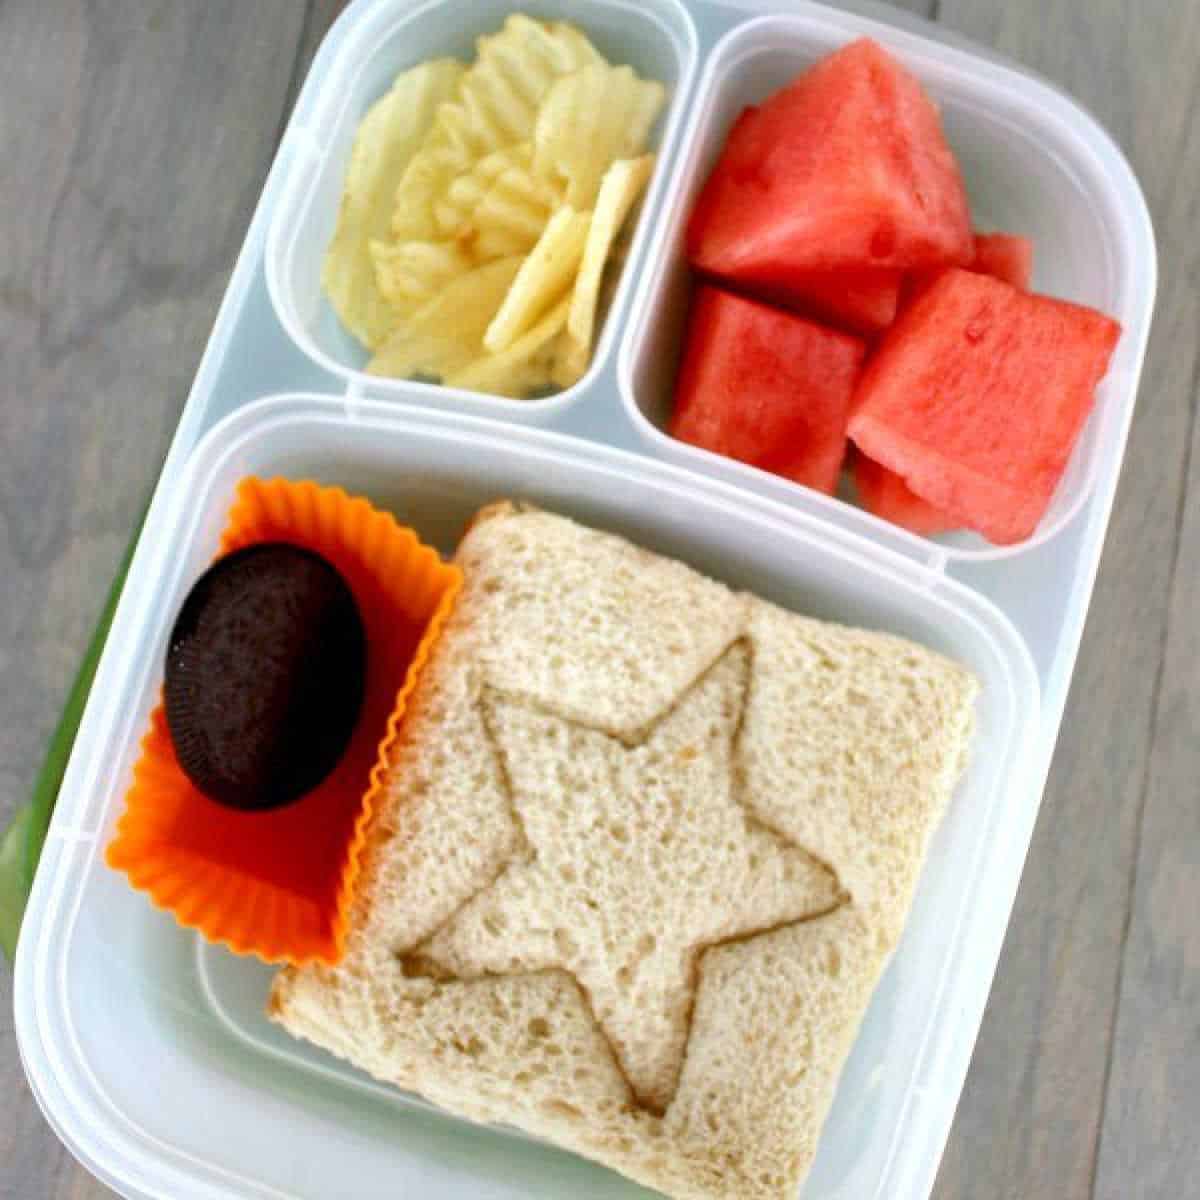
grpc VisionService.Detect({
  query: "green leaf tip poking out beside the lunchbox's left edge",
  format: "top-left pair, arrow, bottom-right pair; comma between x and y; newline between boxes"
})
0,516 -> 145,960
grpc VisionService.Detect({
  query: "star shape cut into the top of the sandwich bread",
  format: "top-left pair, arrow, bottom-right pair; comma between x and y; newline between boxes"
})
406,640 -> 846,1112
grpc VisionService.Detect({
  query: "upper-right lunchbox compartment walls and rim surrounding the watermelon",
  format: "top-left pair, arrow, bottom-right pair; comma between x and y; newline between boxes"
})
619,4 -> 1154,559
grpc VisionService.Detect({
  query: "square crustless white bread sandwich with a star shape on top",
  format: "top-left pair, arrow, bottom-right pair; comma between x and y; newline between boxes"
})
270,505 -> 976,1200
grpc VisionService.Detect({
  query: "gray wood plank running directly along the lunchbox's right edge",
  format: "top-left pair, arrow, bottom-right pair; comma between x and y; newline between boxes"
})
936,0 -> 1200,1200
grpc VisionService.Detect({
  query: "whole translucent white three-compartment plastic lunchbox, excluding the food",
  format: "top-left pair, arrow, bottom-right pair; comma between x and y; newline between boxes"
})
9,0 -> 1154,1200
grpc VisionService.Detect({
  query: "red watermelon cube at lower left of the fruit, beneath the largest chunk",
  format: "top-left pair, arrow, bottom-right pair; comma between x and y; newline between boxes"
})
670,287 -> 865,493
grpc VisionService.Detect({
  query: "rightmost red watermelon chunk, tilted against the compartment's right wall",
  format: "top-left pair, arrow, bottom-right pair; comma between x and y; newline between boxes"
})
850,270 -> 1121,545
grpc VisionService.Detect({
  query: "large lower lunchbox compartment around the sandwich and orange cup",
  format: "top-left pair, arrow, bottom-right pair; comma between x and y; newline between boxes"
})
23,396 -> 1038,1200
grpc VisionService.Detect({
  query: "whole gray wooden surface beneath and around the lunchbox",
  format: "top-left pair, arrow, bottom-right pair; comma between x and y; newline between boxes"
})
0,0 -> 1200,1200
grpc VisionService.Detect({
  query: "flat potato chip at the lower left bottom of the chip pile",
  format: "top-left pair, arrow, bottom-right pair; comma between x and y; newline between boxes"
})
367,256 -> 525,379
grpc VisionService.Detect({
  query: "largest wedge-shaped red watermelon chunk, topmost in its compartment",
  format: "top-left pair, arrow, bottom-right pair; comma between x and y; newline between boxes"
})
688,38 -> 973,288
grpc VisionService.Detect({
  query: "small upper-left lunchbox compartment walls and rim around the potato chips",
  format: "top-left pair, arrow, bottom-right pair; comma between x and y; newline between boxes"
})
265,0 -> 697,420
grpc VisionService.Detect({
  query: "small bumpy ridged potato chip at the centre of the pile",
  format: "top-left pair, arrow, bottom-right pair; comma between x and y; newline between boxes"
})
434,142 -> 562,262
